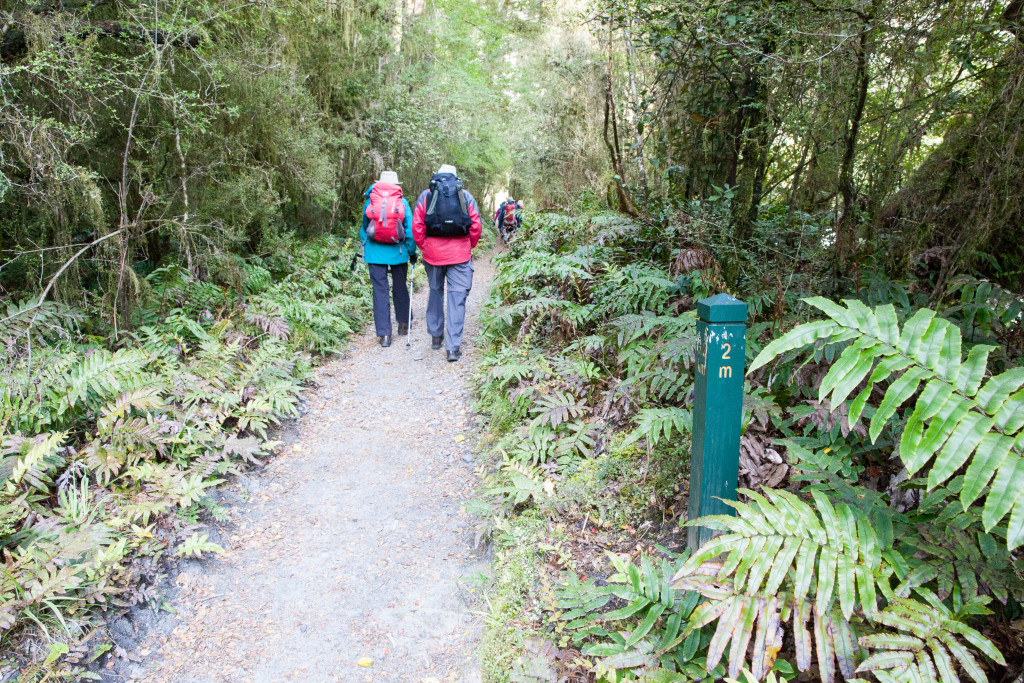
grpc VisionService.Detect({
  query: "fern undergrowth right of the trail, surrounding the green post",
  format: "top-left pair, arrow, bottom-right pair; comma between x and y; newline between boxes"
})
476,207 -> 1024,683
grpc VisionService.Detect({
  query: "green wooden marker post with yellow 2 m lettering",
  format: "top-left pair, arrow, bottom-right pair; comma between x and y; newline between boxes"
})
687,294 -> 746,551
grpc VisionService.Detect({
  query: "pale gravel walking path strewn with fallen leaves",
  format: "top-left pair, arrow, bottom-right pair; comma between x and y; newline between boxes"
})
114,254 -> 492,683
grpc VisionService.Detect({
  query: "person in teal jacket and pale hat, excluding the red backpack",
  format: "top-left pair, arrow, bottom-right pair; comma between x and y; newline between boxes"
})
359,171 -> 418,347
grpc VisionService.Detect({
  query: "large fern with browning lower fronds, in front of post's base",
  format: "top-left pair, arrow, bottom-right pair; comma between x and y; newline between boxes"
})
674,489 -> 1001,683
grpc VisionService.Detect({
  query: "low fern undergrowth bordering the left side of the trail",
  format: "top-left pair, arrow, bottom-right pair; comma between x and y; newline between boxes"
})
0,239 -> 369,681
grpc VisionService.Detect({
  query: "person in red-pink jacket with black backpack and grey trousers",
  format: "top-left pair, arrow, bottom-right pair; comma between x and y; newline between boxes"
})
413,164 -> 481,362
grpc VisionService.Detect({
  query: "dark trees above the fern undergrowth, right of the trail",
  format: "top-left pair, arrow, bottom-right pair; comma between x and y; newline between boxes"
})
545,0 -> 1024,295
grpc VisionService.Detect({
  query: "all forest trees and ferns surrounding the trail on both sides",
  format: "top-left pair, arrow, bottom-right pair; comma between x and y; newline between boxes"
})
0,0 -> 1024,681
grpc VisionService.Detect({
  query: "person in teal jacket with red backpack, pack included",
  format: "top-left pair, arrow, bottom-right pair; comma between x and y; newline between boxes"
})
359,171 -> 417,347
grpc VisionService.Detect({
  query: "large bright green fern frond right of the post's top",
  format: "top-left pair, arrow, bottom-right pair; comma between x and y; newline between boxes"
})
751,297 -> 1024,549
